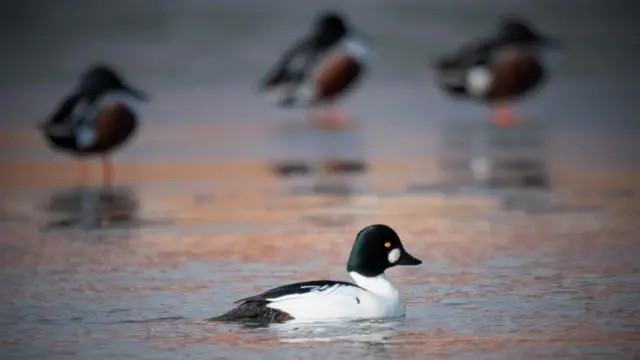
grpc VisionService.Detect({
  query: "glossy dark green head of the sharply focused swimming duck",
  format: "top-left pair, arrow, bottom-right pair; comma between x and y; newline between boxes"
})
347,224 -> 422,277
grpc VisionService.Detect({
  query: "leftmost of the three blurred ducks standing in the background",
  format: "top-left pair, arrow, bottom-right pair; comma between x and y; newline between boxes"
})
40,64 -> 147,185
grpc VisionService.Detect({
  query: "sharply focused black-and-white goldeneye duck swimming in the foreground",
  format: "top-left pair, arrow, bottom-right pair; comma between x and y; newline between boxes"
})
208,224 -> 422,323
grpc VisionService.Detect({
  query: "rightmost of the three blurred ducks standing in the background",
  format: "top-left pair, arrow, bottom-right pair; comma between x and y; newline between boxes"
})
435,17 -> 558,126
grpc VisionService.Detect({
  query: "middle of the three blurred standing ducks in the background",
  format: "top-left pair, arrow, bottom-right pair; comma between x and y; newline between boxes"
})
259,11 -> 370,127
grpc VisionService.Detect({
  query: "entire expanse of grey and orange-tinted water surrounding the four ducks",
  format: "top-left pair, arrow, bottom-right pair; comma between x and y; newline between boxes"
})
0,0 -> 640,358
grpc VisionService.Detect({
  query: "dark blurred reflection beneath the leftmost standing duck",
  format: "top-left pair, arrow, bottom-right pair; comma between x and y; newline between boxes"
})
43,187 -> 139,230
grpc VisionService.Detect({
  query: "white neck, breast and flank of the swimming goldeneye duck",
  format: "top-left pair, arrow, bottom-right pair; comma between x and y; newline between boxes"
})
267,273 -> 405,321
